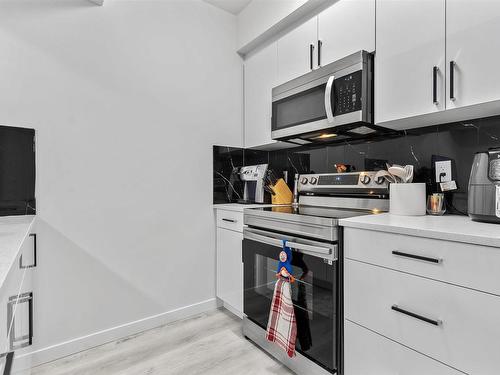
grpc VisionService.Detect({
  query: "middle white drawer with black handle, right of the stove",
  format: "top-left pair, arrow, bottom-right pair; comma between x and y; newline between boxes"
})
344,259 -> 500,375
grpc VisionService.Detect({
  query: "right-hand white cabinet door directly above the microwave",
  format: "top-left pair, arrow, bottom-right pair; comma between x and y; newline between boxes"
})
318,0 -> 375,65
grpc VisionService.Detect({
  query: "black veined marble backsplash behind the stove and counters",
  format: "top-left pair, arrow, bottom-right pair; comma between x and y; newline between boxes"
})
213,116 -> 500,212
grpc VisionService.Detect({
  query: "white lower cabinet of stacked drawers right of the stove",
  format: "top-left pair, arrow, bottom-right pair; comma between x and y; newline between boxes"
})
344,228 -> 500,375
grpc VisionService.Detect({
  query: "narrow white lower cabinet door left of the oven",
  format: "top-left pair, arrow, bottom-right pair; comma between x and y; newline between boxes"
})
217,228 -> 243,316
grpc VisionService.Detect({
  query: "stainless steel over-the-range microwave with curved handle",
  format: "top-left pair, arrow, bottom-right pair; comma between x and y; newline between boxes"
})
271,51 -> 382,144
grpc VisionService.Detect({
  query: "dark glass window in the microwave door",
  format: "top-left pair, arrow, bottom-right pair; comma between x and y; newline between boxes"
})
272,84 -> 326,130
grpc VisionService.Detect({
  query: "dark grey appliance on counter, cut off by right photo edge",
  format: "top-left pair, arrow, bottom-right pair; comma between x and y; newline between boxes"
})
468,148 -> 500,223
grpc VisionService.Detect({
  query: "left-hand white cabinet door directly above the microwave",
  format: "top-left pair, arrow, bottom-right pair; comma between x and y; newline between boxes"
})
278,17 -> 318,84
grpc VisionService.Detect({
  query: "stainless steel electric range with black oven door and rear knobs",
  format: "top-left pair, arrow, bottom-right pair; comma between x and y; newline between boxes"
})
243,172 -> 389,375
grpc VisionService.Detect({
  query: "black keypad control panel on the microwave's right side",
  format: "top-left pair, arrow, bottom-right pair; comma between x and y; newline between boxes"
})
333,70 -> 363,116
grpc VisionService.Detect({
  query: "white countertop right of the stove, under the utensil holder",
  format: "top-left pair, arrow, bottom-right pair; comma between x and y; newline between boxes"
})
340,213 -> 500,247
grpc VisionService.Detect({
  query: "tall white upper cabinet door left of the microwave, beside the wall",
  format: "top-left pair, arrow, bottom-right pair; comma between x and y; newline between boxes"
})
245,43 -> 278,148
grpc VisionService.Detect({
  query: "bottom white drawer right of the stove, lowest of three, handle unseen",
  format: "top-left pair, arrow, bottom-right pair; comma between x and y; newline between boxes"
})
344,320 -> 463,375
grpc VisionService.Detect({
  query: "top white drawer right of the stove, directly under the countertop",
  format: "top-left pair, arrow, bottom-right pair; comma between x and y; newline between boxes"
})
344,227 -> 500,295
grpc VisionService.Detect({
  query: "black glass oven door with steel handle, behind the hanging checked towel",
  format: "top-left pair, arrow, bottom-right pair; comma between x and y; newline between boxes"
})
243,228 -> 339,373
